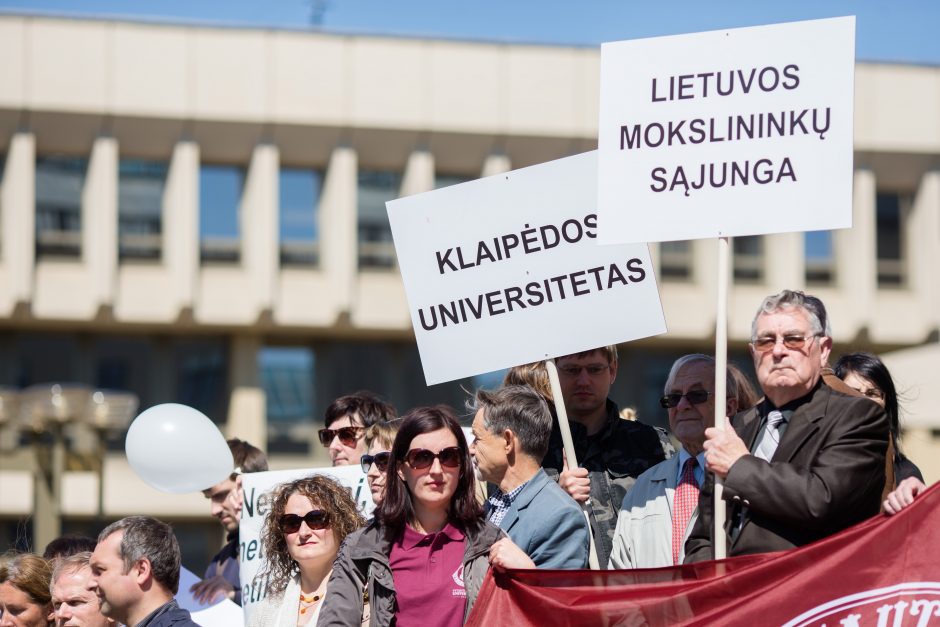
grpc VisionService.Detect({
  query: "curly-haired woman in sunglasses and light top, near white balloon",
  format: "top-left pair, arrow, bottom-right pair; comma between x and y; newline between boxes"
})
249,475 -> 365,627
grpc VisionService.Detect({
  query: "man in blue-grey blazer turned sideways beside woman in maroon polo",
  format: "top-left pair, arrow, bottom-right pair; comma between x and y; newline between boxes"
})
470,386 -> 590,568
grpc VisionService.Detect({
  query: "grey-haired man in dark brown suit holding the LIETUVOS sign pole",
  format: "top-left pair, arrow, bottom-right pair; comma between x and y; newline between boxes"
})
685,290 -> 888,562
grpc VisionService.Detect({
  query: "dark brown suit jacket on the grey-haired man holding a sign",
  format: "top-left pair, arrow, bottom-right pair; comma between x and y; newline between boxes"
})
686,381 -> 888,562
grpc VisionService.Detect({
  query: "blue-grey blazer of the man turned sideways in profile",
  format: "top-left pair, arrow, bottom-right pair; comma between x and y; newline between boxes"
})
499,468 -> 591,569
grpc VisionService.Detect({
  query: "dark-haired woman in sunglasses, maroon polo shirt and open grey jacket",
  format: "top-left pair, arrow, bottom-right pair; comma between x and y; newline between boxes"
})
320,405 -> 505,626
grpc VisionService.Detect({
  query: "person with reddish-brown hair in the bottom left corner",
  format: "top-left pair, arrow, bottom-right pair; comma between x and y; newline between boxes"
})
0,553 -> 55,627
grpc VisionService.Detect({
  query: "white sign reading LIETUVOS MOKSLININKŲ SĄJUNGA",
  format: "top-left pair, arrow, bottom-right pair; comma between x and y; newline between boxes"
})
598,17 -> 855,244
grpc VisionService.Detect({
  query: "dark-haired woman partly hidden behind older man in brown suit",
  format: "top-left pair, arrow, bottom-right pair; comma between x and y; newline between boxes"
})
833,353 -> 924,483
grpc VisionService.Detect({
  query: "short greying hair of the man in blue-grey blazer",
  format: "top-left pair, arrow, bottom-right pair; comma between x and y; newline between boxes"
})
471,385 -> 552,463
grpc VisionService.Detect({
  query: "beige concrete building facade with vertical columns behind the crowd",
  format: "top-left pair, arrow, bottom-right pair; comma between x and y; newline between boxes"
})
0,14 -> 940,556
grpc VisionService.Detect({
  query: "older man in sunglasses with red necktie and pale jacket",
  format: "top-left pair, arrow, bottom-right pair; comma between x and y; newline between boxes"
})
608,354 -> 737,568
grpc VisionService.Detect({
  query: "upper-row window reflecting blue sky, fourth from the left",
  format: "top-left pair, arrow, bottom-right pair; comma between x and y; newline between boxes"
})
278,168 -> 323,265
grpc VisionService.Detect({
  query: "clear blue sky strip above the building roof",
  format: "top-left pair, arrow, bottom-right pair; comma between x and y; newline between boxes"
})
0,0 -> 940,65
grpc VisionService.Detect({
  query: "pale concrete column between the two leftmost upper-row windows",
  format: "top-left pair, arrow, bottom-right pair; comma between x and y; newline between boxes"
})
82,137 -> 118,307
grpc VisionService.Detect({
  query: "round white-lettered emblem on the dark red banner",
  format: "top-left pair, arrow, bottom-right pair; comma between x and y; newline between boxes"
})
783,581 -> 940,627
